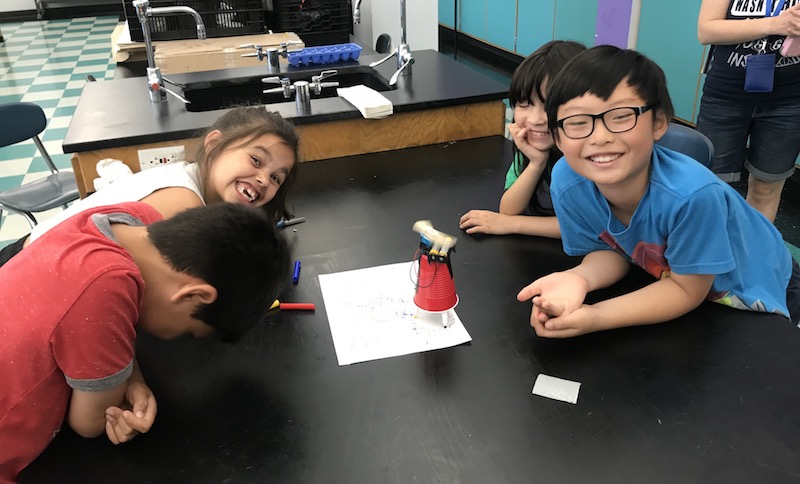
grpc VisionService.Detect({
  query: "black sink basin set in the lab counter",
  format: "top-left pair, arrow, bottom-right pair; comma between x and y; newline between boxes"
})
176,66 -> 393,112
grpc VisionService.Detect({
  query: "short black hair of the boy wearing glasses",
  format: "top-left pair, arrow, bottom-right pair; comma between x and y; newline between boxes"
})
545,45 -> 675,138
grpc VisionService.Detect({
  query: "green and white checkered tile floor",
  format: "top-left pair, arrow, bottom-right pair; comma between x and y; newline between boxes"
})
0,17 -> 119,247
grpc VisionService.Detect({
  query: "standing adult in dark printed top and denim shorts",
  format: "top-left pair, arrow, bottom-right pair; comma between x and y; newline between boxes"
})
697,0 -> 800,221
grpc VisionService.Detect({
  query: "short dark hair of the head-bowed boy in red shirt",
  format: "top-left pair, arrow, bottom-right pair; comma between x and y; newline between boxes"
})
147,203 -> 289,342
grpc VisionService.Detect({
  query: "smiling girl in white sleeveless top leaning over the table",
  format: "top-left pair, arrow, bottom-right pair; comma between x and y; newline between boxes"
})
0,106 -> 299,266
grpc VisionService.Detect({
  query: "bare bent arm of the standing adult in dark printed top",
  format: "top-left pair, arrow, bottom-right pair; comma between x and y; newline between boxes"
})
697,0 -> 800,45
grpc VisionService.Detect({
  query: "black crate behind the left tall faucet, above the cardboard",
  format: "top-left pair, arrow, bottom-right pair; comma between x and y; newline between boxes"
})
122,0 -> 266,42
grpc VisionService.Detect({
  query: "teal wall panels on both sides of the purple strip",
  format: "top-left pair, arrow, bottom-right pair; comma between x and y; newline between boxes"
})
439,0 -> 706,123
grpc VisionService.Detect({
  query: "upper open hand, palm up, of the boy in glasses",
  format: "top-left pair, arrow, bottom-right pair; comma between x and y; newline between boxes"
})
517,272 -> 588,330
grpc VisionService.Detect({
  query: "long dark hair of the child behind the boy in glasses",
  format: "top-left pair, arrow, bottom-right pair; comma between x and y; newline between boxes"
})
508,40 -> 586,215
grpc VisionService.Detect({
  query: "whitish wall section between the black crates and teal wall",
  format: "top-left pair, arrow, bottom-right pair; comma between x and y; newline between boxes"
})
353,0 -> 439,54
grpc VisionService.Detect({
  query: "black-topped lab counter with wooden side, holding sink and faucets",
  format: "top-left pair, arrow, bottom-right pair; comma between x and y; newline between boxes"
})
63,50 -> 508,195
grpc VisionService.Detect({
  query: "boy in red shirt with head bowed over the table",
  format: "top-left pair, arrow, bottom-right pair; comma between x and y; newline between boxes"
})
0,202 -> 289,483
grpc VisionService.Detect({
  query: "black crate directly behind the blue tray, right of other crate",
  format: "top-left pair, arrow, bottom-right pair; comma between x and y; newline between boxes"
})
273,0 -> 353,46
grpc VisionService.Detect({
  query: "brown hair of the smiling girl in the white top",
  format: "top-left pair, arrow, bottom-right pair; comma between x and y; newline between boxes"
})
195,106 -> 300,222
